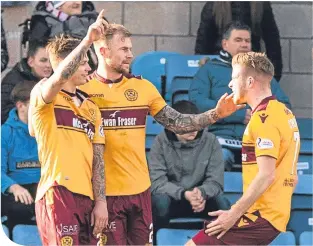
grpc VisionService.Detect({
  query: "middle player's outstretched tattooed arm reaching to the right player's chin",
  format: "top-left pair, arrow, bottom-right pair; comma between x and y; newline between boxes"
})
154,93 -> 245,134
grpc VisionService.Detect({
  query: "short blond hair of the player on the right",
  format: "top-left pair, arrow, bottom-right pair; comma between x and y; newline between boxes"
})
232,52 -> 274,77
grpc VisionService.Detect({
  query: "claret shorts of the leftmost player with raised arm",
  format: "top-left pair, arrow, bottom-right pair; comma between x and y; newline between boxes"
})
35,186 -> 98,245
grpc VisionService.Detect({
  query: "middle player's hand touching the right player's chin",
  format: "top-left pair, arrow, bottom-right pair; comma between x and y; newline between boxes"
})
215,93 -> 246,118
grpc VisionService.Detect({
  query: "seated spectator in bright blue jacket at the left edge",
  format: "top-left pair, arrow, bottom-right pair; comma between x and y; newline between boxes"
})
1,81 -> 40,235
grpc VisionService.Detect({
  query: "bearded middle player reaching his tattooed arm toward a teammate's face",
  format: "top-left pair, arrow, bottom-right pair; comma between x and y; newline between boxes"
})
80,24 -> 243,245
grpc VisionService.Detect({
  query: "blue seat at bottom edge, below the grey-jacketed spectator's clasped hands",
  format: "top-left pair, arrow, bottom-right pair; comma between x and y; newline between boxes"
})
157,228 -> 198,245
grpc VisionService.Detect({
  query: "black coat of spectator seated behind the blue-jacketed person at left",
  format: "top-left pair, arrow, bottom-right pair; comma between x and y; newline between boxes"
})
1,58 -> 40,124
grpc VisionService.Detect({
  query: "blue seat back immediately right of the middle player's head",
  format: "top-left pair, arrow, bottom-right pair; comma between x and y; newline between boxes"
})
131,51 -> 178,97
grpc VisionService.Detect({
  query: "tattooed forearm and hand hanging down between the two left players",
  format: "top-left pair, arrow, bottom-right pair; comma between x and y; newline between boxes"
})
91,144 -> 108,236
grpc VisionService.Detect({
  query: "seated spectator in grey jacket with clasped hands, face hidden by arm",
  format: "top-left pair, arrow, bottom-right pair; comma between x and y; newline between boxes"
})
148,101 -> 230,242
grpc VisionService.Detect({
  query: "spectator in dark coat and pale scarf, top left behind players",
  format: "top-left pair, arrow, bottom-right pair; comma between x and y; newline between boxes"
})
22,1 -> 108,71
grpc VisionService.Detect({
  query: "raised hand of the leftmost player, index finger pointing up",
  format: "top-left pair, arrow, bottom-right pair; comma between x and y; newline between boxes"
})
86,9 -> 108,42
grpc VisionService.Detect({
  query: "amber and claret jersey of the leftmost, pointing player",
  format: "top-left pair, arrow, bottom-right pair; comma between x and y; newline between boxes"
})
29,83 -> 105,201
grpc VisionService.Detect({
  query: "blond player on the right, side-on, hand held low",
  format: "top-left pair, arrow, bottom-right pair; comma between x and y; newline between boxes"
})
186,52 -> 300,246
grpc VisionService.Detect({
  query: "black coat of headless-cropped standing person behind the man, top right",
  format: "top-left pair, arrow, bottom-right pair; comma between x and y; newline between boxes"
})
195,2 -> 283,81
